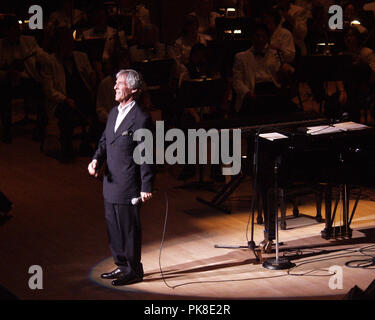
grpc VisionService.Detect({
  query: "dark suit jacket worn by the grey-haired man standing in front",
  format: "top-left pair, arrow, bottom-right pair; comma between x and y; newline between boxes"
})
93,103 -> 154,204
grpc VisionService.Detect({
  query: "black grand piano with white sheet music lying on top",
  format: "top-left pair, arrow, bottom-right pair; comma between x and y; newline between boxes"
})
258,121 -> 375,239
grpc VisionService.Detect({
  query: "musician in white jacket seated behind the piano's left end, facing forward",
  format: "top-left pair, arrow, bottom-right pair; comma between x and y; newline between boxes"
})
233,24 -> 295,115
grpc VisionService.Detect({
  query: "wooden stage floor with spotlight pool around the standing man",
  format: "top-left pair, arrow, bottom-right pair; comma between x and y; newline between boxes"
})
0,122 -> 375,300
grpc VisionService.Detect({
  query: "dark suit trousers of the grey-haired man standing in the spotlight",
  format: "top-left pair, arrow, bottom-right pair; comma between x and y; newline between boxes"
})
104,201 -> 143,278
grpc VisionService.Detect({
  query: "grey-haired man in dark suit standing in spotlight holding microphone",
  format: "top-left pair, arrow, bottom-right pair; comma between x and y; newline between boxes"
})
88,70 -> 154,286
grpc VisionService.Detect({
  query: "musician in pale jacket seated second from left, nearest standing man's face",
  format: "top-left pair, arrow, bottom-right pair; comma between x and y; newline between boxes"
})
41,27 -> 96,162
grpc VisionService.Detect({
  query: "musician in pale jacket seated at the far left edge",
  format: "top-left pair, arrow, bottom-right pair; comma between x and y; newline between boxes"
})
0,16 -> 44,143
